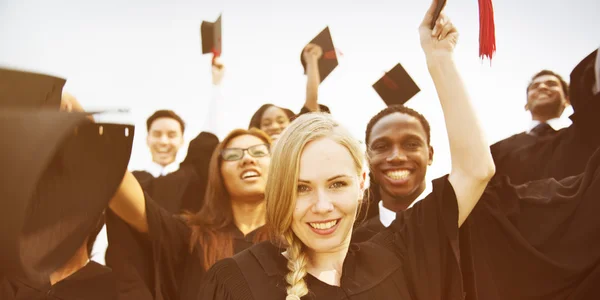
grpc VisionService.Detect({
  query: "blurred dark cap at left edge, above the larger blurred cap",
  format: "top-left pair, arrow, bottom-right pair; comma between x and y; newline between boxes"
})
0,68 -> 66,110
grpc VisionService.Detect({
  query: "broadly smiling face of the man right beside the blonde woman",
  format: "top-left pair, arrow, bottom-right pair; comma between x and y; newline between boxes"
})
368,112 -> 433,204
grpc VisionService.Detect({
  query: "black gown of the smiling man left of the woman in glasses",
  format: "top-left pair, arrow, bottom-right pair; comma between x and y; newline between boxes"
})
106,132 -> 219,300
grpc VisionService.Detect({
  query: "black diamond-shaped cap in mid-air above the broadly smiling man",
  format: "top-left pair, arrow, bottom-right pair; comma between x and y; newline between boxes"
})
373,64 -> 421,106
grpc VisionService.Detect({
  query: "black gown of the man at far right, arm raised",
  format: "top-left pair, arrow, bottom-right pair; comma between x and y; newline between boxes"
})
491,51 -> 600,184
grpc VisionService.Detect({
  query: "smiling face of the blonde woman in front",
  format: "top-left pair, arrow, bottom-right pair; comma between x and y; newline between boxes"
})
291,138 -> 364,252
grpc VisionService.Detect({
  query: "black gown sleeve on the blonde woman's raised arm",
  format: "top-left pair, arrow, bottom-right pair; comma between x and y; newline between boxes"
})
372,175 -> 464,299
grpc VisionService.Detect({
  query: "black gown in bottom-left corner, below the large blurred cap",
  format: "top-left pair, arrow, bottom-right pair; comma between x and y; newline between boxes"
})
0,261 -> 117,300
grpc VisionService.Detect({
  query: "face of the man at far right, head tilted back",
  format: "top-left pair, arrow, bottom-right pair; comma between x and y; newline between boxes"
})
525,75 -> 569,119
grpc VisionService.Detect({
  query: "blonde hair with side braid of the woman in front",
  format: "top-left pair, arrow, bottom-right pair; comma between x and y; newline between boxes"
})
265,113 -> 365,300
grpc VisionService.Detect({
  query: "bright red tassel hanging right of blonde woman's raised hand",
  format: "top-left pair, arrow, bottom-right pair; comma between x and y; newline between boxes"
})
479,0 -> 496,62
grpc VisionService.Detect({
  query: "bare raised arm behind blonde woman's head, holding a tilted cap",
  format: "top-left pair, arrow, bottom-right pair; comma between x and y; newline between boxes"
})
303,44 -> 323,112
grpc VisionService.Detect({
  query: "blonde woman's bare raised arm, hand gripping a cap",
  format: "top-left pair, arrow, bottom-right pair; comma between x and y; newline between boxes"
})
419,0 -> 495,227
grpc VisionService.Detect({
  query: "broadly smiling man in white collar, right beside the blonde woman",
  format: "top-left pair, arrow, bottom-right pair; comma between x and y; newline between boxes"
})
353,105 -> 433,242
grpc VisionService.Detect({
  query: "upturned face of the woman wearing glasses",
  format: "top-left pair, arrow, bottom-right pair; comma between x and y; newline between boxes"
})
221,134 -> 271,201
